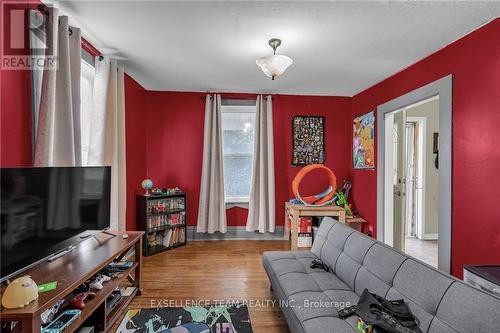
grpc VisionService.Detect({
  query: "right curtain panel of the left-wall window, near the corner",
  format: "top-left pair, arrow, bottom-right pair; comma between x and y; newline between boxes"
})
87,57 -> 127,230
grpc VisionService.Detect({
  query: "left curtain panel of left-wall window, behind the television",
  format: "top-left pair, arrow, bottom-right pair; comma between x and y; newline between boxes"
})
34,8 -> 81,166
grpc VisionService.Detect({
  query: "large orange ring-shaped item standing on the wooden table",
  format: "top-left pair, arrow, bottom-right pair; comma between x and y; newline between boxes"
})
292,164 -> 337,206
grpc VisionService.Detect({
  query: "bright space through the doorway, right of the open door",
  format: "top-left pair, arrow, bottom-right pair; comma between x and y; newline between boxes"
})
403,96 -> 439,268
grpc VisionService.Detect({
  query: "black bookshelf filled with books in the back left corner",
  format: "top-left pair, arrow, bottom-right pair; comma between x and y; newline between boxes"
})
136,192 -> 187,256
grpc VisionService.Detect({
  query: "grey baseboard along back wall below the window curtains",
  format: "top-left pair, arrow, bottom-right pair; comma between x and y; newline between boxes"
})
187,226 -> 283,241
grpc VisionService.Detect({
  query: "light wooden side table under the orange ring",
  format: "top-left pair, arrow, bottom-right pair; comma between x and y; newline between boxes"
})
283,202 -> 346,251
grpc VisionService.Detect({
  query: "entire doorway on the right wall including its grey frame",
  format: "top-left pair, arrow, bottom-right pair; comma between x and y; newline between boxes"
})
377,76 -> 451,272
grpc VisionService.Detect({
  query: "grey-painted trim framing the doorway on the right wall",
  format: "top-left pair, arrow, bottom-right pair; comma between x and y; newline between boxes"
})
377,75 -> 453,273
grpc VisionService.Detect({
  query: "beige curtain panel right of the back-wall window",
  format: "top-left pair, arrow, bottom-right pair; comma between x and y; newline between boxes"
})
246,96 -> 275,233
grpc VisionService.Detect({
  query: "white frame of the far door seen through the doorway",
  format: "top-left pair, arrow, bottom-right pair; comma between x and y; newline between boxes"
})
406,116 -> 427,239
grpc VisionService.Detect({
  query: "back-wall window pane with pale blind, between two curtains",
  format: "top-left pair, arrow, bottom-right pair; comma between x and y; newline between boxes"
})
222,105 -> 255,203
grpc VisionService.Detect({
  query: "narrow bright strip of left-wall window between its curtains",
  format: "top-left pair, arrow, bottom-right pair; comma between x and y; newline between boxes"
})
80,59 -> 95,165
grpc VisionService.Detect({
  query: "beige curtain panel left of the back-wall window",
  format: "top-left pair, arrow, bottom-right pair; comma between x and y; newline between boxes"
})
196,95 -> 227,233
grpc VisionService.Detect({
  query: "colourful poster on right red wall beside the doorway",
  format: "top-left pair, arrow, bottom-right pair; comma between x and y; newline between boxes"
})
352,111 -> 375,169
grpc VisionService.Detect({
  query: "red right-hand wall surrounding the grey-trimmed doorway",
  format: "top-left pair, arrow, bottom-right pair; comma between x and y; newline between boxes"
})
351,19 -> 500,277
